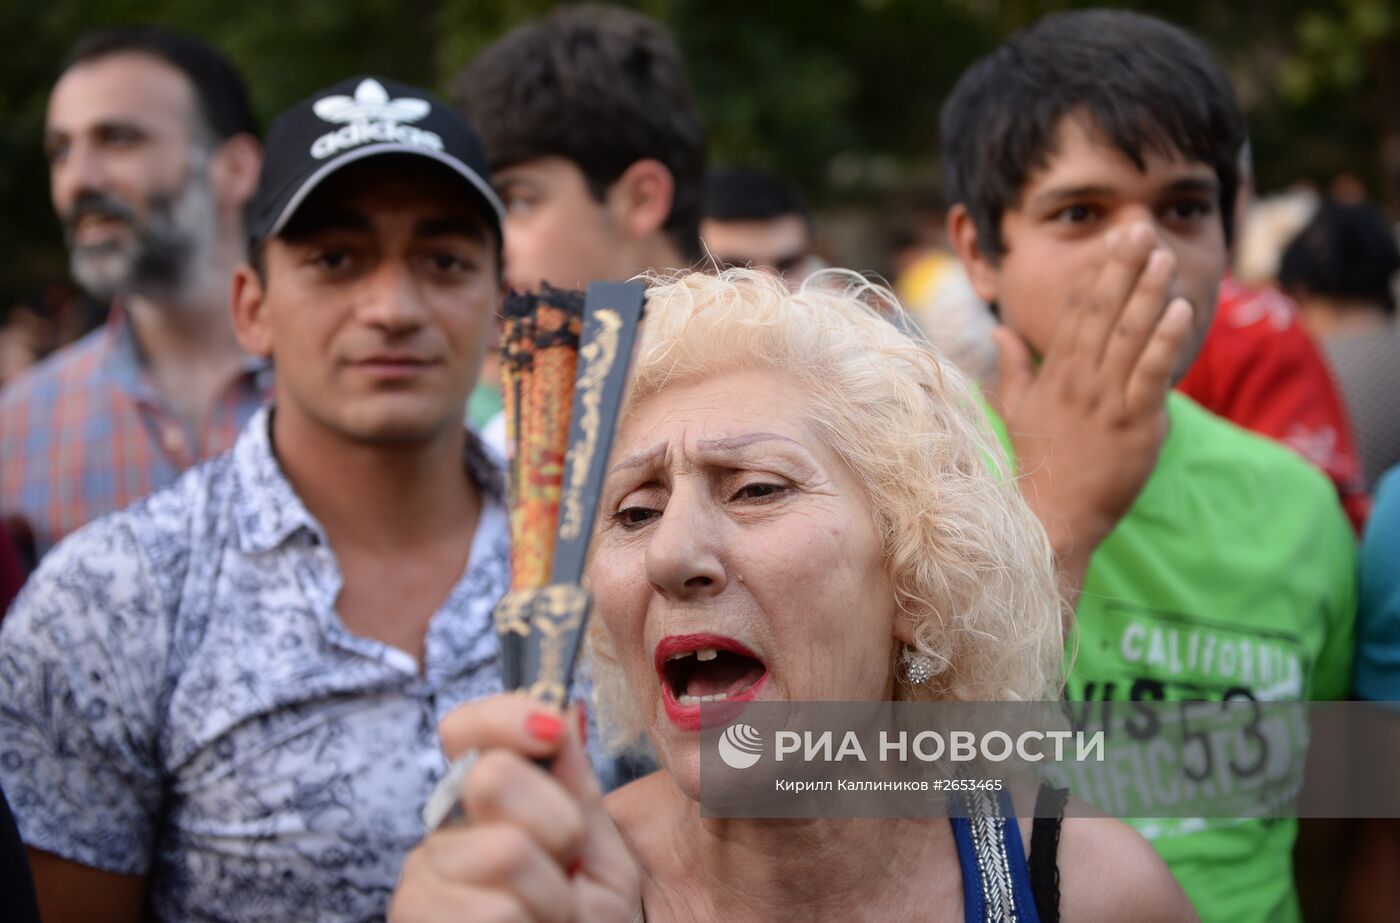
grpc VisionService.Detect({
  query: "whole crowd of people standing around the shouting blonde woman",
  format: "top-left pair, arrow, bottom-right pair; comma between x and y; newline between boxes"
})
0,6 -> 1400,923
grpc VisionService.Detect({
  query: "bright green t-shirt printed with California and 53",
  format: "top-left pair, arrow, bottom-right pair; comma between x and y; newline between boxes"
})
998,394 -> 1357,923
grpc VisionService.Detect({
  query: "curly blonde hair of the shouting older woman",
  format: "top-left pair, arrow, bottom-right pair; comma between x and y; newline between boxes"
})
589,269 -> 1064,748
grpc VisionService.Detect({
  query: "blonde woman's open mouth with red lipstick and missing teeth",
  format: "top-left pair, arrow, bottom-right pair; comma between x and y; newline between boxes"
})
655,634 -> 769,730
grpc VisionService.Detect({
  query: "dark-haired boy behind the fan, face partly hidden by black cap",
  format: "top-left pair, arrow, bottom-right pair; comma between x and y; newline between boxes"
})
455,4 -> 704,290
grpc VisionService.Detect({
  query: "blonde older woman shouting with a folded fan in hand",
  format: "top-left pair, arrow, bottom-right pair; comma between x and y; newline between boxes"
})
391,270 -> 1194,923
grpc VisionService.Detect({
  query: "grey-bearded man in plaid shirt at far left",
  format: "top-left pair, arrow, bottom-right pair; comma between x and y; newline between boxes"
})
0,27 -> 266,556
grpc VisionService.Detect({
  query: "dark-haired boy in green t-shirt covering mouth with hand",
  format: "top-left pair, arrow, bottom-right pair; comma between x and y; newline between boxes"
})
942,10 -> 1355,923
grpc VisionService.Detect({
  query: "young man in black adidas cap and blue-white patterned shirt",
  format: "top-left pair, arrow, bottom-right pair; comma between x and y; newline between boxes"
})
0,78 -> 508,920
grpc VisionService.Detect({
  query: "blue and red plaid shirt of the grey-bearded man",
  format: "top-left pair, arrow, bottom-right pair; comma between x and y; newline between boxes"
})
0,308 -> 269,557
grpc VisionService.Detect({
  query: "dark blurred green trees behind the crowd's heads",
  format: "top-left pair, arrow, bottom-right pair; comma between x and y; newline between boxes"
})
0,0 -> 1400,315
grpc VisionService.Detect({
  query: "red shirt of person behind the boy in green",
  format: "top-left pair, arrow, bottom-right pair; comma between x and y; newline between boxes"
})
1177,276 -> 1371,534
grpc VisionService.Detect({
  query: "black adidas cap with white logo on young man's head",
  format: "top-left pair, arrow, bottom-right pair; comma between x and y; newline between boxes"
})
248,77 -> 505,240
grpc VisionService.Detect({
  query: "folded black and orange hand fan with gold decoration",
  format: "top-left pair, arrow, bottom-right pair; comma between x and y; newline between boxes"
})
423,283 -> 645,831
